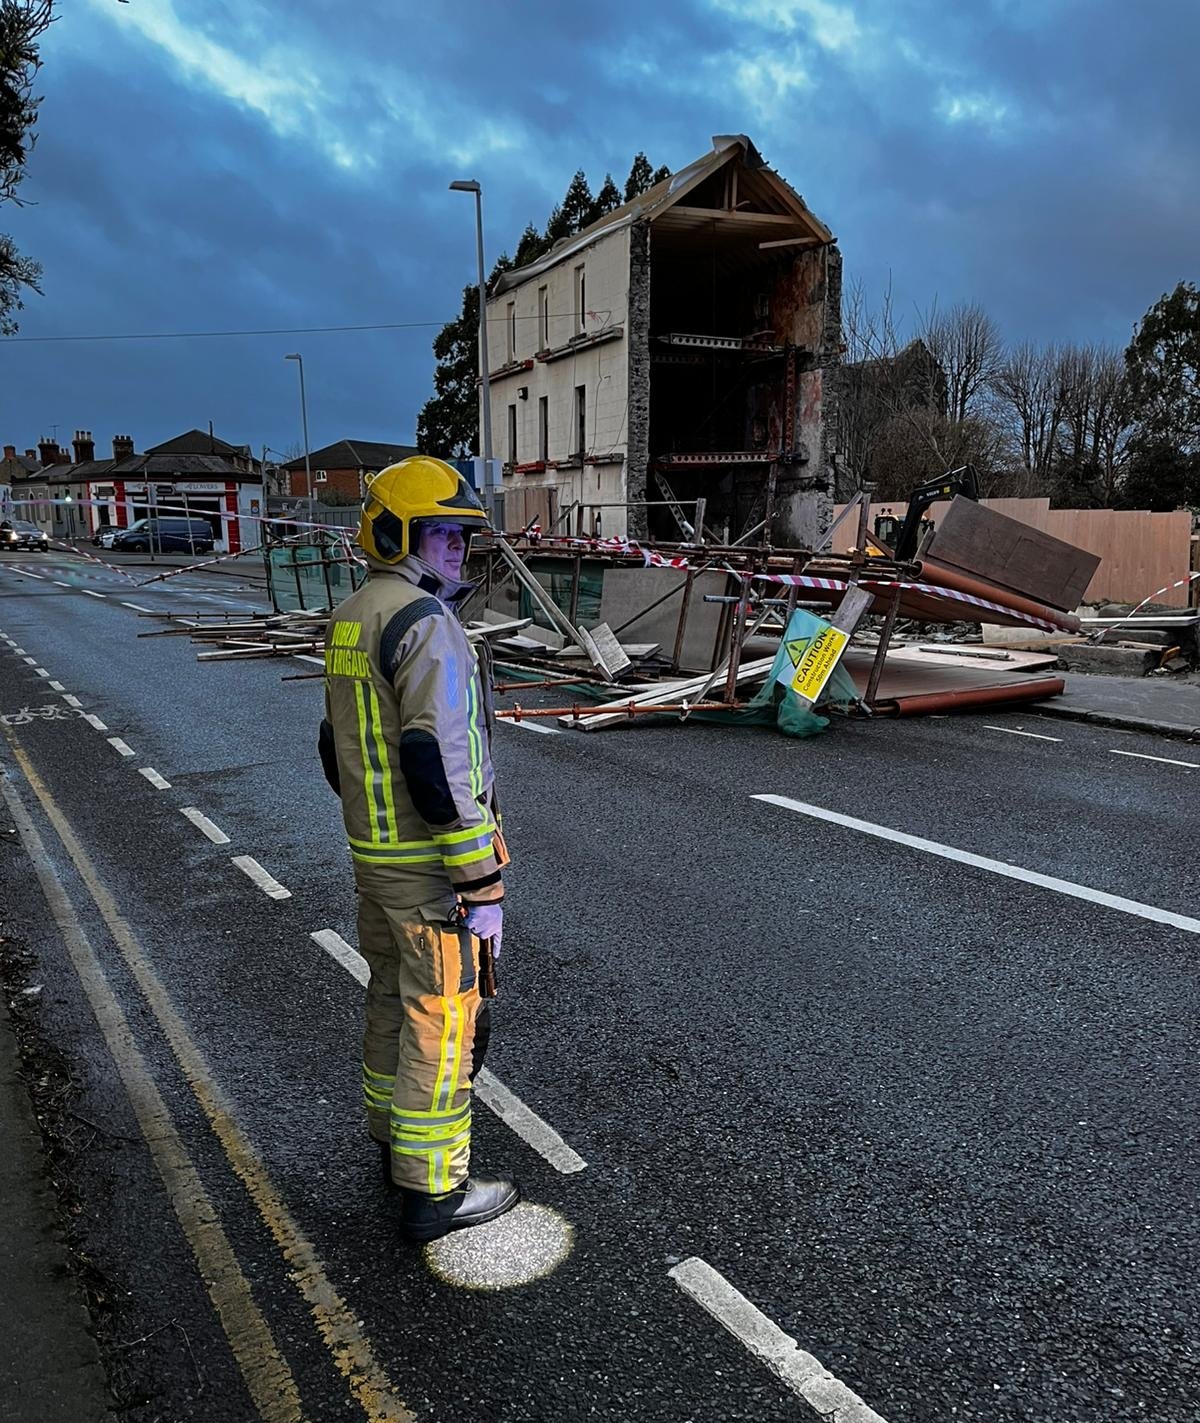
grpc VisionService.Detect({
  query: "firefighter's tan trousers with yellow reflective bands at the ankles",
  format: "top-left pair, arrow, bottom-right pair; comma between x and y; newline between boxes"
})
359,895 -> 487,1195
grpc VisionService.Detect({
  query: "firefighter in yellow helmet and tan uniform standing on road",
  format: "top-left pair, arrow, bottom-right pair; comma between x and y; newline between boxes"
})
320,455 -> 520,1241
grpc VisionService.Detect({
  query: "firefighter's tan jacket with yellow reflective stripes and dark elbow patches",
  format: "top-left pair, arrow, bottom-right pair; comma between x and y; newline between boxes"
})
325,556 -> 505,909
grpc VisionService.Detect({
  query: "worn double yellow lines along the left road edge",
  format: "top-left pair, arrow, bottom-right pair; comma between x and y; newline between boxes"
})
0,727 -> 414,1423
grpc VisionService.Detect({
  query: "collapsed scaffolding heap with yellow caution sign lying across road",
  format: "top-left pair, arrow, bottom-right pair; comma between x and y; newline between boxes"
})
161,477 -> 1098,734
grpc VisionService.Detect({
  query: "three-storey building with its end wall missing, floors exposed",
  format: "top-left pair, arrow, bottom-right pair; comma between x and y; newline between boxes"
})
487,135 -> 841,546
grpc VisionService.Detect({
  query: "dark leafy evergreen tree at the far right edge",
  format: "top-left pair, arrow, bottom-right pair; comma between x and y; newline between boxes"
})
1125,282 -> 1200,454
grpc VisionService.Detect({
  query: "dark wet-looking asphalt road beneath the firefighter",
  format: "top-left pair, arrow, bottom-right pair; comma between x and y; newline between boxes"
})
0,555 -> 1200,1423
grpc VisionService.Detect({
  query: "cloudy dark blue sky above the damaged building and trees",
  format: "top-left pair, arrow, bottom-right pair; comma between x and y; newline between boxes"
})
0,0 -> 1200,455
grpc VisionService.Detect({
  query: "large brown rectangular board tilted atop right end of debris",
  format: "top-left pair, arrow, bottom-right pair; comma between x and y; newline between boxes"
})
925,495 -> 1100,612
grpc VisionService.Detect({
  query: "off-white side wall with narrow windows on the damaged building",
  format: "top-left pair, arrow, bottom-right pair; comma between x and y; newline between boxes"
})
487,228 -> 629,536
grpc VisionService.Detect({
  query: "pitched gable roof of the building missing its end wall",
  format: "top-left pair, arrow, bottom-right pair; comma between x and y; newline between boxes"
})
488,134 -> 836,296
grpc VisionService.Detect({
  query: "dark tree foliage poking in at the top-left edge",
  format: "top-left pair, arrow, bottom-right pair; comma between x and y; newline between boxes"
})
0,0 -> 54,336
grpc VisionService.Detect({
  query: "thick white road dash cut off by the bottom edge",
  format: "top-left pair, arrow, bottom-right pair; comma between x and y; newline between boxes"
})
668,1255 -> 885,1423
